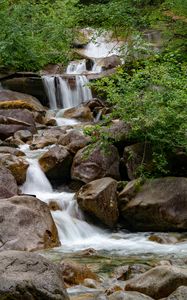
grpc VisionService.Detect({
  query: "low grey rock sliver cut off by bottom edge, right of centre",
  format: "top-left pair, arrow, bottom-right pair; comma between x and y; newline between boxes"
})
108,292 -> 153,300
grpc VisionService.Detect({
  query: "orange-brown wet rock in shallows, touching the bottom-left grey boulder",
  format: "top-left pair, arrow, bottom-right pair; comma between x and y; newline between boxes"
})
60,261 -> 98,285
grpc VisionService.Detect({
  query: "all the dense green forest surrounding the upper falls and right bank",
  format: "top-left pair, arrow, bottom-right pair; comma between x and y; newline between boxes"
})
0,0 -> 187,176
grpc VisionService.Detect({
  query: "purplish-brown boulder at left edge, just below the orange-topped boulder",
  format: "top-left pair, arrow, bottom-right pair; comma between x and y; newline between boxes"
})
0,108 -> 36,139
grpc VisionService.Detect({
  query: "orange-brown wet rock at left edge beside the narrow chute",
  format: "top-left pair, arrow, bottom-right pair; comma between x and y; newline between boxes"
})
0,153 -> 29,185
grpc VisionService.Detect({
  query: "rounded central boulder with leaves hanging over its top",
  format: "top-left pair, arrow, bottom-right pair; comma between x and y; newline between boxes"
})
71,145 -> 120,183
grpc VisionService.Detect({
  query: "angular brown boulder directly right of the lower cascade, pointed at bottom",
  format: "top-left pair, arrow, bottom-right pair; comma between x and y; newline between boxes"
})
77,177 -> 119,227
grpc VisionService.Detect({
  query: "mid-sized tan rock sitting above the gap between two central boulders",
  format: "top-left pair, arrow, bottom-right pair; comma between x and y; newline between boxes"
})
58,129 -> 90,154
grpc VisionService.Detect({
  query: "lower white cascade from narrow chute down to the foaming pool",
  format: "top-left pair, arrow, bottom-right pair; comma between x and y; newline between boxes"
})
21,145 -> 187,256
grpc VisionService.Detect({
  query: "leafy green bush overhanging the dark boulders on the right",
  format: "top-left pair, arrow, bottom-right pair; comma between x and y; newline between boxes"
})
89,52 -> 187,174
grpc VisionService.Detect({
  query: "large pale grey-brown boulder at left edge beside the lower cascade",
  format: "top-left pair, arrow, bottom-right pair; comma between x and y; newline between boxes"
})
0,195 -> 59,251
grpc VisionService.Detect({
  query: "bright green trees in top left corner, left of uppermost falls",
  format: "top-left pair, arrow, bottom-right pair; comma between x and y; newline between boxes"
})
0,0 -> 77,70
